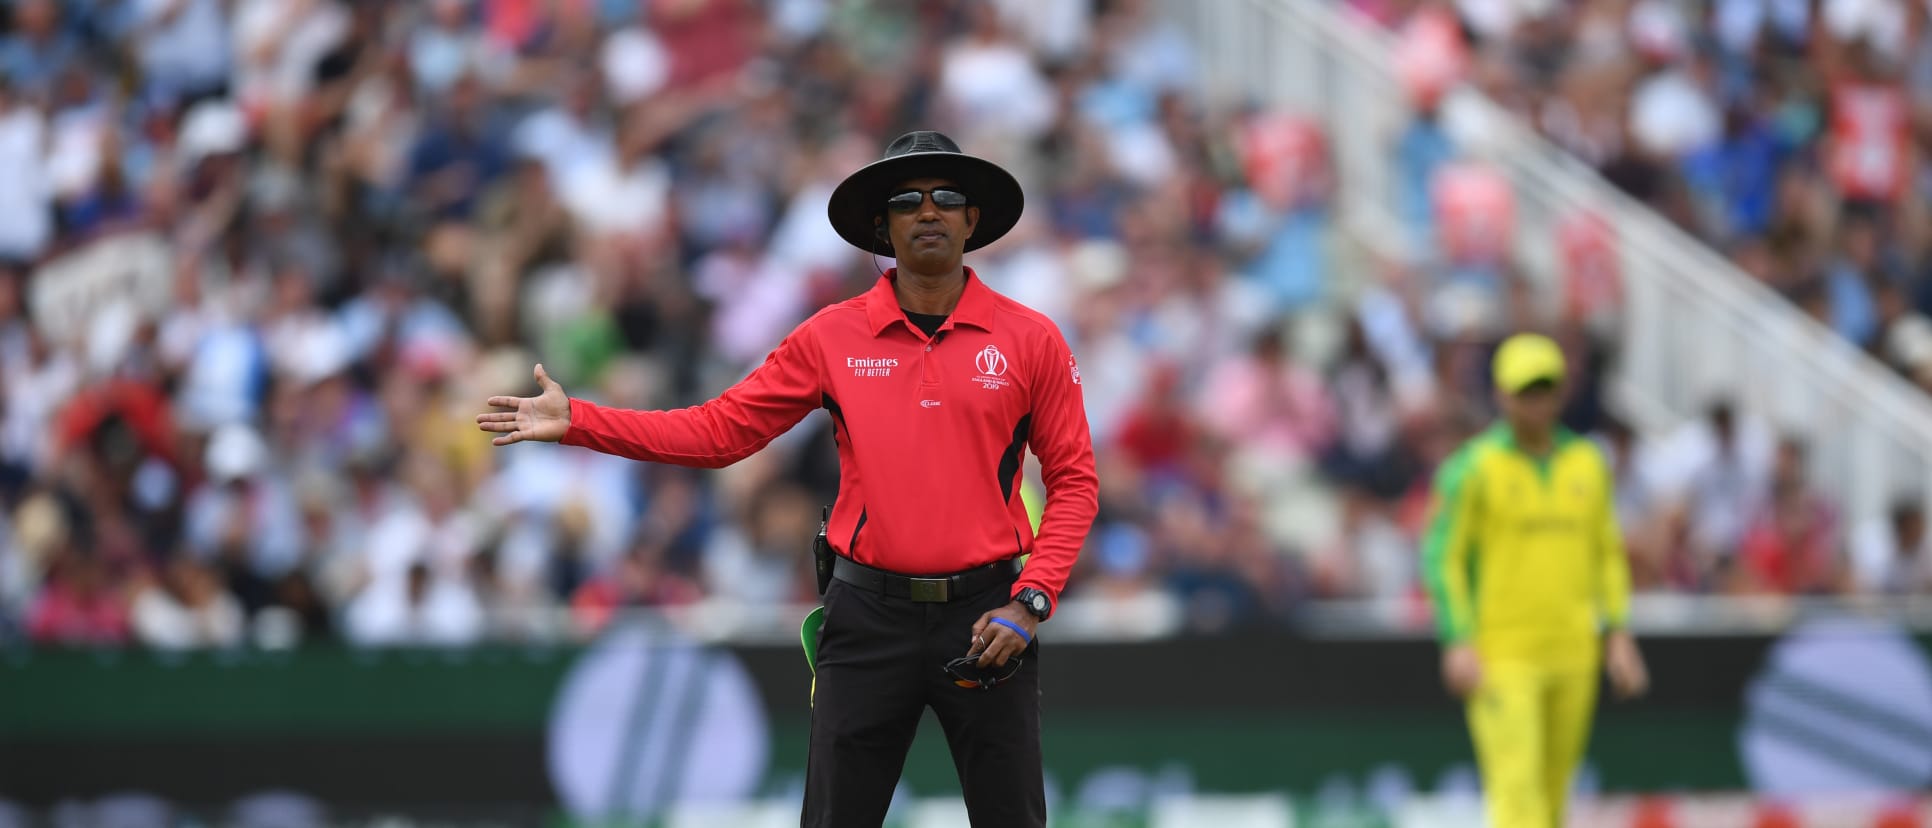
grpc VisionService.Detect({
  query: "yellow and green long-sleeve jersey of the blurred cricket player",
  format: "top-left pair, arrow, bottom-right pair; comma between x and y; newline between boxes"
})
1422,425 -> 1631,662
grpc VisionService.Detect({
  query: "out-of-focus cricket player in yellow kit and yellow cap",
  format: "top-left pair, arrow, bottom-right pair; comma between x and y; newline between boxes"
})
1422,334 -> 1648,828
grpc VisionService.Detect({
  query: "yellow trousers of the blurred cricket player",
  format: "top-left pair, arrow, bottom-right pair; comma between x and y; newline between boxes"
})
1468,660 -> 1598,828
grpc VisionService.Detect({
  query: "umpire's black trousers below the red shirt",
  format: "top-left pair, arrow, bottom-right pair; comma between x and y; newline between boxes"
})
800,581 -> 1047,828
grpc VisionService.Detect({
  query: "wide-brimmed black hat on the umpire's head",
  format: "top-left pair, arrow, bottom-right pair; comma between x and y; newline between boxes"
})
825,129 -> 1026,257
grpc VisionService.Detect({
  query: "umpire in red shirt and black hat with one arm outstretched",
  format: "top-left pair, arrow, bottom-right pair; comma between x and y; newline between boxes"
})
477,131 -> 1097,828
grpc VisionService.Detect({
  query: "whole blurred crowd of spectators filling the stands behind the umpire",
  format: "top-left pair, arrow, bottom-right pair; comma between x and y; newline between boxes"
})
0,0 -> 1932,647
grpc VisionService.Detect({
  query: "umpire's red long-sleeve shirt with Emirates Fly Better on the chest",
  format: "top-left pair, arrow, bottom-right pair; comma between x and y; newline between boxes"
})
564,268 -> 1099,604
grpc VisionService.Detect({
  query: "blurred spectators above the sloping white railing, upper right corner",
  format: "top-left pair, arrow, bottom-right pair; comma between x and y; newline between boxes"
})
1367,0 -> 1932,390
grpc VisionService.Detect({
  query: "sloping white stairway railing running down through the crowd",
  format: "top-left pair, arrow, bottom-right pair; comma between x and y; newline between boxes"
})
1165,0 -> 1932,521
